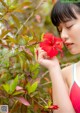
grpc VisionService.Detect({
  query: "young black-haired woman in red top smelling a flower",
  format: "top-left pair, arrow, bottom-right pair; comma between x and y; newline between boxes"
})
37,1 -> 80,113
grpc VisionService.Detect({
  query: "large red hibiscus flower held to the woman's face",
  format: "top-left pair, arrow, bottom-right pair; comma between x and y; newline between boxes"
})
40,33 -> 63,58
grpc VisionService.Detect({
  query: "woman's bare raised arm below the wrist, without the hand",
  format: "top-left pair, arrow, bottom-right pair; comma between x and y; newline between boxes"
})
49,67 -> 75,113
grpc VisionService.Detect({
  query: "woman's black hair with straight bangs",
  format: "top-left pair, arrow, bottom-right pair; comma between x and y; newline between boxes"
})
51,0 -> 80,26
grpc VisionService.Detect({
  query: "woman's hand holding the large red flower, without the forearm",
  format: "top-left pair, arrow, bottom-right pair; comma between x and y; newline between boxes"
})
36,47 -> 60,70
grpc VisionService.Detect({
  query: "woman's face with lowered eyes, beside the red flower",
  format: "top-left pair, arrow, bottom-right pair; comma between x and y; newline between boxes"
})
58,11 -> 80,54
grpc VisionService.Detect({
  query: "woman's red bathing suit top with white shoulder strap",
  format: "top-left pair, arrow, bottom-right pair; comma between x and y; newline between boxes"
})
70,64 -> 80,113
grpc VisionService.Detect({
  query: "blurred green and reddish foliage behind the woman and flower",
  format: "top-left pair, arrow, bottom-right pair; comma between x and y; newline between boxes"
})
0,0 -> 80,113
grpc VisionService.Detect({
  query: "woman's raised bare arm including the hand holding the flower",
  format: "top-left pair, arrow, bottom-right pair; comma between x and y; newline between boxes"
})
37,48 -> 75,113
